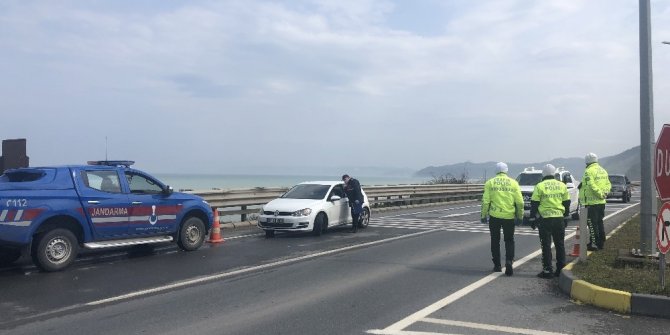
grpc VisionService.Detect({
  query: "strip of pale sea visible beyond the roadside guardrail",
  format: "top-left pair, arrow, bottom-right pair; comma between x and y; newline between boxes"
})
154,173 -> 430,191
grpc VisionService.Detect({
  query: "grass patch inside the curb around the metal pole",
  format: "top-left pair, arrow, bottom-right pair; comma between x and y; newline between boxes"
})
573,215 -> 670,297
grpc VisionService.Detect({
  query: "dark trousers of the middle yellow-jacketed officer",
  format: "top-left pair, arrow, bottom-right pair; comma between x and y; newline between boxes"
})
537,217 -> 565,272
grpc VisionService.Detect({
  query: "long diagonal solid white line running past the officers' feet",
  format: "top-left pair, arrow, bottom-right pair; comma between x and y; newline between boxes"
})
368,203 -> 639,334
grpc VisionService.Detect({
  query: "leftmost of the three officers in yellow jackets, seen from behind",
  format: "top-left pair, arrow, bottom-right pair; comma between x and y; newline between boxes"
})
481,162 -> 523,276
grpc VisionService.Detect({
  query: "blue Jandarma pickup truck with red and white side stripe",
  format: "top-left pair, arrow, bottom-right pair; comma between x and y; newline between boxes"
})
0,161 -> 213,271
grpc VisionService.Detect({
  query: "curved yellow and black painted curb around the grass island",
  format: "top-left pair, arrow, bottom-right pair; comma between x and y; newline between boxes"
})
558,207 -> 670,319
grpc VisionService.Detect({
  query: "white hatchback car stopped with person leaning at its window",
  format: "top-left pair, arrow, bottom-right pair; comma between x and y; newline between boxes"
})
258,181 -> 370,237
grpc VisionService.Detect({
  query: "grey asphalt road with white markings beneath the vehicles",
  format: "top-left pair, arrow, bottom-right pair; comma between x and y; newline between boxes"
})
0,190 -> 670,334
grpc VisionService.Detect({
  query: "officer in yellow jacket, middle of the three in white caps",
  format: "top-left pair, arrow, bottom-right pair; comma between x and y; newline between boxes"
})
530,164 -> 570,278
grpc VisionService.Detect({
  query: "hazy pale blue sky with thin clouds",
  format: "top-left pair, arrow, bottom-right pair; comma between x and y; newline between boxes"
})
0,0 -> 670,174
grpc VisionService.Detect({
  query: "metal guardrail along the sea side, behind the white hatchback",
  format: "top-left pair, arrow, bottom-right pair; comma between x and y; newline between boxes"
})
188,184 -> 484,221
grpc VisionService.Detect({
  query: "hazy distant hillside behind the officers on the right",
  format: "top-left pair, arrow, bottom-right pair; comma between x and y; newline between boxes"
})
414,146 -> 640,180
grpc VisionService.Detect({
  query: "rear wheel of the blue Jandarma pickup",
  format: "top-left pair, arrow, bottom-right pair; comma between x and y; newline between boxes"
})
31,228 -> 79,272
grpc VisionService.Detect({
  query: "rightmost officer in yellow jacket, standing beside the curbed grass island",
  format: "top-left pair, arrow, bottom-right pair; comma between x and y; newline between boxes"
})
579,152 -> 612,251
